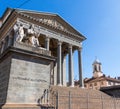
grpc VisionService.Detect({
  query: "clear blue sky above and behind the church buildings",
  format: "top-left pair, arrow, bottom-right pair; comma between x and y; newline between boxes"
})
0,0 -> 120,79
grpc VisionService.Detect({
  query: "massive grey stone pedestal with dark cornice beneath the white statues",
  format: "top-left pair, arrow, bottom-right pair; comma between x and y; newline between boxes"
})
0,47 -> 55,109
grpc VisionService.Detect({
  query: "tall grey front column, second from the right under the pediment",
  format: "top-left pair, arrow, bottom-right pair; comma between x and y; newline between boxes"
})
69,45 -> 74,87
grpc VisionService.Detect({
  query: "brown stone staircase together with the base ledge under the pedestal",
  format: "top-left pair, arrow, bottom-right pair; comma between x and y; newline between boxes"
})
2,86 -> 120,109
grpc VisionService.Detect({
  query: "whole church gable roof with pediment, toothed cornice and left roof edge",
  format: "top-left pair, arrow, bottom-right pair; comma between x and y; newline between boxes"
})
0,8 -> 86,41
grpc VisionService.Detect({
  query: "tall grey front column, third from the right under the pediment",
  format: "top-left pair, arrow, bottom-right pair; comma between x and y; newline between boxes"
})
57,41 -> 62,86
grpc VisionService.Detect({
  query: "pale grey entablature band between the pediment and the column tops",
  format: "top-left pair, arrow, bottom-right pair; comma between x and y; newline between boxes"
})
16,18 -> 81,47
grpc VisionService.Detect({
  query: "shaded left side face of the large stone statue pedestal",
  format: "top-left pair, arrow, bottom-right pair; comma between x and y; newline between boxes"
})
0,56 -> 11,105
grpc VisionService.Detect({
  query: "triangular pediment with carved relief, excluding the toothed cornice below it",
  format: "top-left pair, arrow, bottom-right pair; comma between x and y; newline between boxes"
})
17,10 -> 85,39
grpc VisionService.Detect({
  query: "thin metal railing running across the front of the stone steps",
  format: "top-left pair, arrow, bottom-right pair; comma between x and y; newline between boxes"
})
39,89 -> 120,109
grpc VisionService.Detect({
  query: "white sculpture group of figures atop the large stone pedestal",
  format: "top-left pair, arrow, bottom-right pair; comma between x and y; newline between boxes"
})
14,24 -> 40,47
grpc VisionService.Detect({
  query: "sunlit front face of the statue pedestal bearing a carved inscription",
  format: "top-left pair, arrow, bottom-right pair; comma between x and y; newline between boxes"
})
7,54 -> 51,104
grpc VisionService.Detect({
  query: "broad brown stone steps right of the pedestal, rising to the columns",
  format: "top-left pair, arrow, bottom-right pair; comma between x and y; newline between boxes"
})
49,86 -> 120,109
